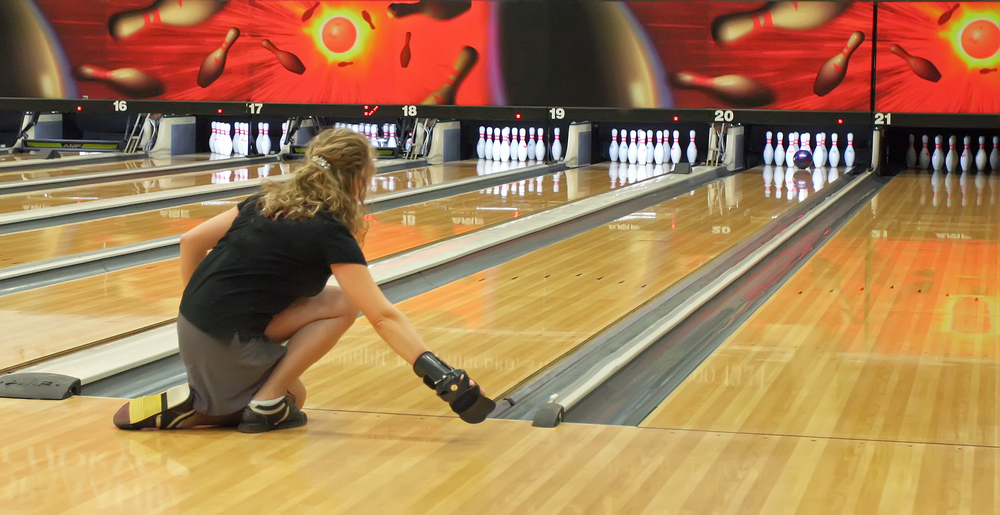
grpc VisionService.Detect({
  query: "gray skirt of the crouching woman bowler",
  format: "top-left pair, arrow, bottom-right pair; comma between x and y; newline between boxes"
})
177,315 -> 285,416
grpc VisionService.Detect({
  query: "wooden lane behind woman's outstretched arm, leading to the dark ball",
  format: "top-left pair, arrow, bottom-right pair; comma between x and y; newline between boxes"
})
294,169 -> 844,415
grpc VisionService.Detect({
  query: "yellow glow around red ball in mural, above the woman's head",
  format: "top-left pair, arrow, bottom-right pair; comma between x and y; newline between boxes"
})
302,5 -> 371,63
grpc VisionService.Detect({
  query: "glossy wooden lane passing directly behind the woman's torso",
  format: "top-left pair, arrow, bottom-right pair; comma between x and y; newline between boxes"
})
0,161 -> 584,370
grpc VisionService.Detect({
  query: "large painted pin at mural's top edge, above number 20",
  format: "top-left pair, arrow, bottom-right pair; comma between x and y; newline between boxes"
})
712,1 -> 851,45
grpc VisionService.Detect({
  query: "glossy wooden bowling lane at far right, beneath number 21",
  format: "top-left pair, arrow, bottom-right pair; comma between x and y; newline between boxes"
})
644,173 -> 1000,448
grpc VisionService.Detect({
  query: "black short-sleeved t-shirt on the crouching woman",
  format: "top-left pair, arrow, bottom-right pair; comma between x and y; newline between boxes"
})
180,195 -> 366,342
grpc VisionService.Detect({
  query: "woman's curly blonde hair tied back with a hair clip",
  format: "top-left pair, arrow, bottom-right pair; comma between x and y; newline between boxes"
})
261,129 -> 375,243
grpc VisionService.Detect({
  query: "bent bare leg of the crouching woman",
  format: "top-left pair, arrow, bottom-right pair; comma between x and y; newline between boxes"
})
254,286 -> 358,407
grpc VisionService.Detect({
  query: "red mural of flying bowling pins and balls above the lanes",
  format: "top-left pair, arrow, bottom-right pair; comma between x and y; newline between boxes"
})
0,0 -> 1000,113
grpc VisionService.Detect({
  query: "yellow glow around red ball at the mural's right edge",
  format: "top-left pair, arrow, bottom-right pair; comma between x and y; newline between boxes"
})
941,7 -> 1000,68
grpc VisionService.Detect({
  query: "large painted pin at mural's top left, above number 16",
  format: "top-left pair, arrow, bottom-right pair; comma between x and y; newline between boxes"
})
108,0 -> 229,39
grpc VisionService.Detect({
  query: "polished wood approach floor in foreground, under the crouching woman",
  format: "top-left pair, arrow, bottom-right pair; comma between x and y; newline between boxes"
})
0,398 -> 1000,515
